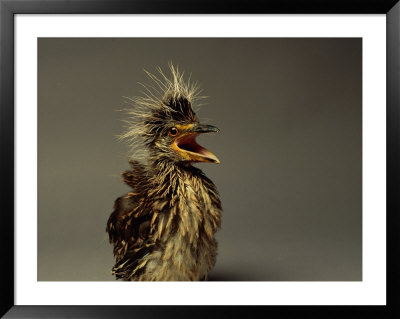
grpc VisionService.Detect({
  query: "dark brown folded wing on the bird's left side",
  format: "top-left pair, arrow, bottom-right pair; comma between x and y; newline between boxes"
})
106,161 -> 154,279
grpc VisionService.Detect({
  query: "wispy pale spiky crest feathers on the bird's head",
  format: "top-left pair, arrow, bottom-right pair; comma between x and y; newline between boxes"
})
119,63 -> 205,159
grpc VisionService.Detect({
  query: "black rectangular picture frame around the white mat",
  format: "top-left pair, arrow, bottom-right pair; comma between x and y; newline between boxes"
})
0,0 -> 400,318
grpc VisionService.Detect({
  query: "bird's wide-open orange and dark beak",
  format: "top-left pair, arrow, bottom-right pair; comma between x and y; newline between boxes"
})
172,124 -> 220,164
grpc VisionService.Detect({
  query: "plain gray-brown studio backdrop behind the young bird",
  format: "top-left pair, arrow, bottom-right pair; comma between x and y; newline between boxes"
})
38,38 -> 362,281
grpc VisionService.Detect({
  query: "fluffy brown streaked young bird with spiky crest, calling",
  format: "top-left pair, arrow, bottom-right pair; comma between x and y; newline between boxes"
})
106,63 -> 222,281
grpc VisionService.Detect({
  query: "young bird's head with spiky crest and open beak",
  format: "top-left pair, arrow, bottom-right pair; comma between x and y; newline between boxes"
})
123,64 -> 219,163
